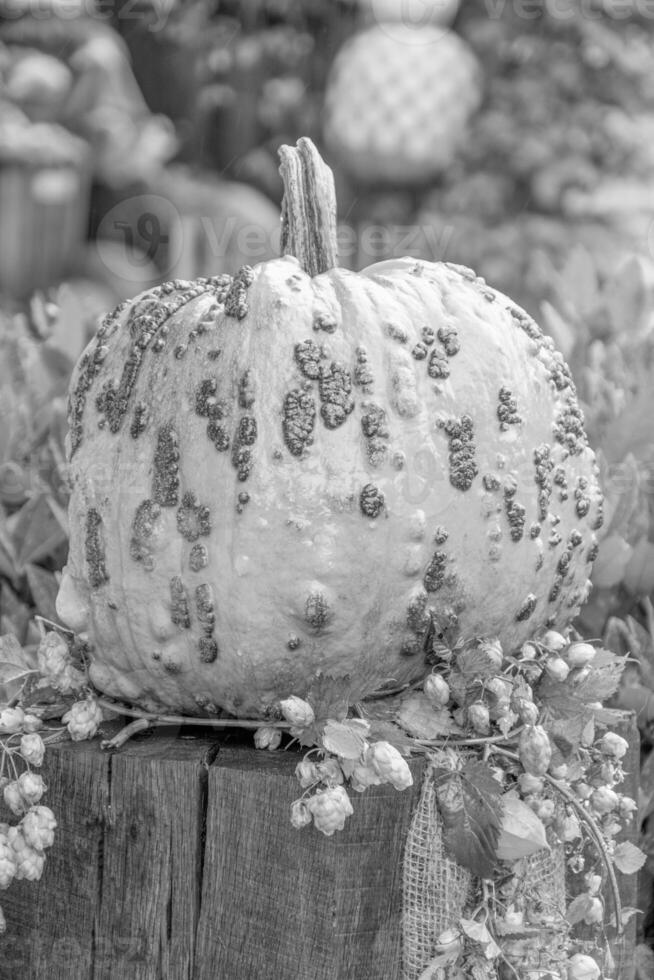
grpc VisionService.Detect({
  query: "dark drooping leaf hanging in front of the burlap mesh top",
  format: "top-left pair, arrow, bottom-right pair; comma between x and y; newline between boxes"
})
434,762 -> 502,878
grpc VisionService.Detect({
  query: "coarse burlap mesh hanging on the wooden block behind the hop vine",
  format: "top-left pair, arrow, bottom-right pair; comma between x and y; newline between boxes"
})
402,762 -> 567,980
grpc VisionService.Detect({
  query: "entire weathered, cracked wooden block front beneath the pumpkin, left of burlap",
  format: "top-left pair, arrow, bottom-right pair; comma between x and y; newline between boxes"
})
0,733 -> 421,980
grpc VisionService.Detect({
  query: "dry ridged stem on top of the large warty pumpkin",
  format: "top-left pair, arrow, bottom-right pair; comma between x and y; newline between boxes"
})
279,136 -> 338,276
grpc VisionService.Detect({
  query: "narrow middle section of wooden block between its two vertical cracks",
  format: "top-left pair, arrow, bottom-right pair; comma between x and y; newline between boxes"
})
92,736 -> 215,980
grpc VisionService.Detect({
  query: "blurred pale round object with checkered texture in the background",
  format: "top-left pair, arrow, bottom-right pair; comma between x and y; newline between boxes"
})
324,23 -> 481,185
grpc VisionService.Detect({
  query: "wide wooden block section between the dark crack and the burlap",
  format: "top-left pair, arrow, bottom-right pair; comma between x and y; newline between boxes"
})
196,749 -> 421,980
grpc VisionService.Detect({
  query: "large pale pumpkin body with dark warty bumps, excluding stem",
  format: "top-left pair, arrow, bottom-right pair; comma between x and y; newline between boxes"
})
58,256 -> 601,717
